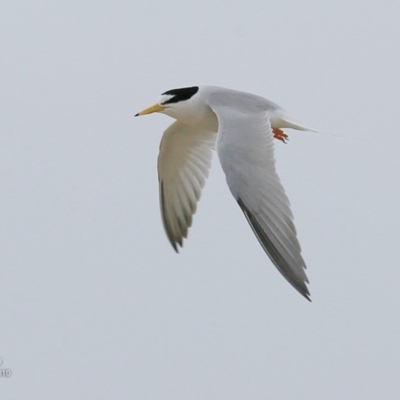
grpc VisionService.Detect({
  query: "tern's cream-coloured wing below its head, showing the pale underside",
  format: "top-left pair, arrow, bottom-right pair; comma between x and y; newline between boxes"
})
158,121 -> 217,251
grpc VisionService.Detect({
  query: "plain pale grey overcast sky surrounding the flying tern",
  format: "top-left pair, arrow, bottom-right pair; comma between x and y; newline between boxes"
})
0,0 -> 400,400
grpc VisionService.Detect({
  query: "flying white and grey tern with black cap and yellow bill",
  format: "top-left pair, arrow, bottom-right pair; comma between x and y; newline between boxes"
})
135,86 -> 312,300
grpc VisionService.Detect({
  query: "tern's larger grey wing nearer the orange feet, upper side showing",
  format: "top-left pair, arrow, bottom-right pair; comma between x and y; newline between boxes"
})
210,95 -> 309,299
